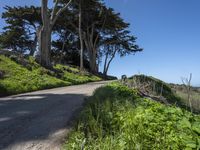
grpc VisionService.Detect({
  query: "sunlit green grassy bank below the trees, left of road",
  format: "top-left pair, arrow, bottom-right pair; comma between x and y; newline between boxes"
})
0,55 -> 101,96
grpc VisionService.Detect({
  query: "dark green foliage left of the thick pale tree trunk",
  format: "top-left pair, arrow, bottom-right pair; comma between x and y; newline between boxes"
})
0,6 -> 41,55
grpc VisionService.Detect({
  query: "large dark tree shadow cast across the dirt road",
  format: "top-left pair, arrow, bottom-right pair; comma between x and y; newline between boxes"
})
0,94 -> 85,149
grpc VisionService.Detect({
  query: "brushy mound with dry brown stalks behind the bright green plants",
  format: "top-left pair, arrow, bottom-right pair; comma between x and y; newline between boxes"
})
124,75 -> 200,113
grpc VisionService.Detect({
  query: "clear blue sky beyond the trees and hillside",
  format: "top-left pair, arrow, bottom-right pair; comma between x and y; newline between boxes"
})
0,0 -> 200,85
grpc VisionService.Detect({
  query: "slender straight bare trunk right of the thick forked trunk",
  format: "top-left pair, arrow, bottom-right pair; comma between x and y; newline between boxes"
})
79,0 -> 83,70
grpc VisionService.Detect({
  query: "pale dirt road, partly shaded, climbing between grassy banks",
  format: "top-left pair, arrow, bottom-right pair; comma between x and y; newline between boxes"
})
0,81 -> 106,150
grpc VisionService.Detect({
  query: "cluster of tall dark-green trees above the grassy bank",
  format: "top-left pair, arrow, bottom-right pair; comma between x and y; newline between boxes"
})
0,0 -> 142,76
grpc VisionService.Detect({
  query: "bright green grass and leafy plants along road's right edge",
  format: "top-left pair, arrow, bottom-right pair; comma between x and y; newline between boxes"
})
63,83 -> 200,150
